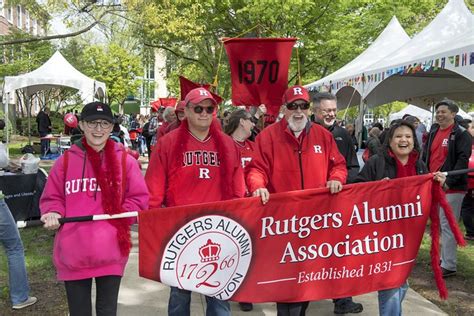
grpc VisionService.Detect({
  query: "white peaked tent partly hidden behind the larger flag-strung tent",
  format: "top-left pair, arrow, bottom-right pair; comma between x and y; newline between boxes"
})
305,16 -> 410,107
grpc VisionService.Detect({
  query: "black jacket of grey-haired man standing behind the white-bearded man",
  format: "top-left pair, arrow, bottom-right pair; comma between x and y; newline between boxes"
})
328,124 -> 360,183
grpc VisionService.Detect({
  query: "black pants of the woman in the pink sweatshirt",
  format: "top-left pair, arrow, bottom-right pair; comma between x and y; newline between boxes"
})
64,275 -> 122,316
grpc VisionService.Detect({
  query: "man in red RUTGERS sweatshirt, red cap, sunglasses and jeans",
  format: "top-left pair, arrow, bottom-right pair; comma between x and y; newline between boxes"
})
145,88 -> 245,316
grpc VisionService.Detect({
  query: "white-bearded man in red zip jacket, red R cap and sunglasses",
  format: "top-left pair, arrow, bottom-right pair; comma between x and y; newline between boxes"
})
246,86 -> 347,316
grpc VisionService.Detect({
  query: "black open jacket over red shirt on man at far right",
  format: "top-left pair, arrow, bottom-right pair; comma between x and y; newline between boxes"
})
423,122 -> 472,190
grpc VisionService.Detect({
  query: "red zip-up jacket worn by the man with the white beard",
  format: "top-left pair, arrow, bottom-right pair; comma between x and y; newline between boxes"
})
246,119 -> 347,193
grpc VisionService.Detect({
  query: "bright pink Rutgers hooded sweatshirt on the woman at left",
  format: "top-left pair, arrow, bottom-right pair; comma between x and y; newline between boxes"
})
40,144 -> 148,281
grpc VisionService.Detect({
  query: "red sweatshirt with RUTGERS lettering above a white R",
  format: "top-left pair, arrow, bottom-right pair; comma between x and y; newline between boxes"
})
145,121 -> 245,208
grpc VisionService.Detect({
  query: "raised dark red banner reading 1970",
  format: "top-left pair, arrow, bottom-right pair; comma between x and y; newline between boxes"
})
224,38 -> 296,116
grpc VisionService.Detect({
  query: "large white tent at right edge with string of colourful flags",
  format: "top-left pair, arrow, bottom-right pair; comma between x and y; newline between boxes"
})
362,0 -> 474,108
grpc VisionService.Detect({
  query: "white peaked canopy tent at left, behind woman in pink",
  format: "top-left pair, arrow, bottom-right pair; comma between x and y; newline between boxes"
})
3,51 -> 105,103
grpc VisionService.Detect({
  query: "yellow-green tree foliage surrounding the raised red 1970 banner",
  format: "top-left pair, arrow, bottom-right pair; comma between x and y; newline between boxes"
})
127,0 -> 447,98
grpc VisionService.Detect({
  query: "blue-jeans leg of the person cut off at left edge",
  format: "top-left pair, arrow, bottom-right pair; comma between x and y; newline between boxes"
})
0,199 -> 30,305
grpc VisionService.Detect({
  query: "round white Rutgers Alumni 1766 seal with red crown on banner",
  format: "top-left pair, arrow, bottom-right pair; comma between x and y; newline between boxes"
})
160,215 -> 252,300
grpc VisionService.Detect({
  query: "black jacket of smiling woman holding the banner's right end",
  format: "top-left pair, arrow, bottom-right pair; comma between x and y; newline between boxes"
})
355,152 -> 428,182
